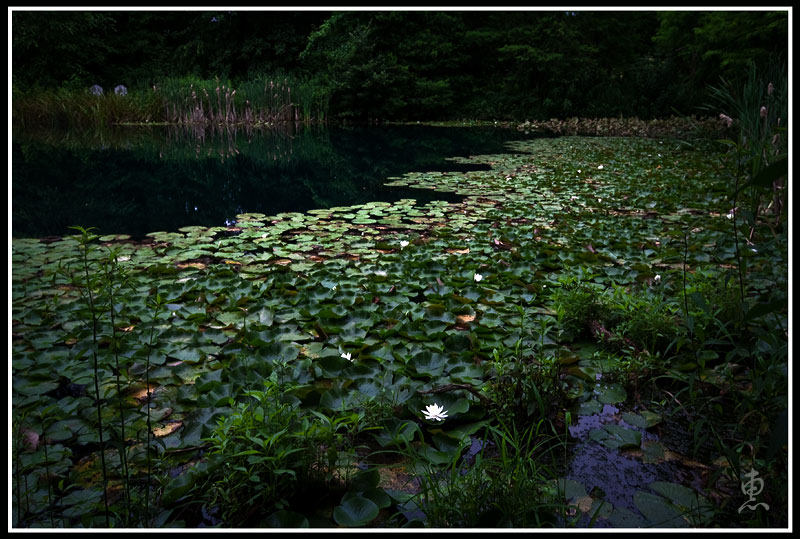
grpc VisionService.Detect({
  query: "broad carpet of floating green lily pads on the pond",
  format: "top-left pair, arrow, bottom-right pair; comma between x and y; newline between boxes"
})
11,137 -> 764,524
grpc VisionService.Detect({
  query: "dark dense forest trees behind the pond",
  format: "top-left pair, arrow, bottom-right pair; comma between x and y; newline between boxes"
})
11,11 -> 788,120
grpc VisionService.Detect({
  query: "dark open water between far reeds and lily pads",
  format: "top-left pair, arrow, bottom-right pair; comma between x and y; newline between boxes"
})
11,126 -> 526,238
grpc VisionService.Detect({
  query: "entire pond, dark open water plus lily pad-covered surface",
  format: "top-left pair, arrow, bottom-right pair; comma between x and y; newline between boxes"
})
11,127 -> 788,528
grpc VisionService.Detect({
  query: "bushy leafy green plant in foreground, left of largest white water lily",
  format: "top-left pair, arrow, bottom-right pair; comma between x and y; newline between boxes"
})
195,378 -> 368,526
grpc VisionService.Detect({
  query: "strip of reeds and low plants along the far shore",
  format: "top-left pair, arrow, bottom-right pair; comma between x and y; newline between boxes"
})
12,78 -> 730,139
